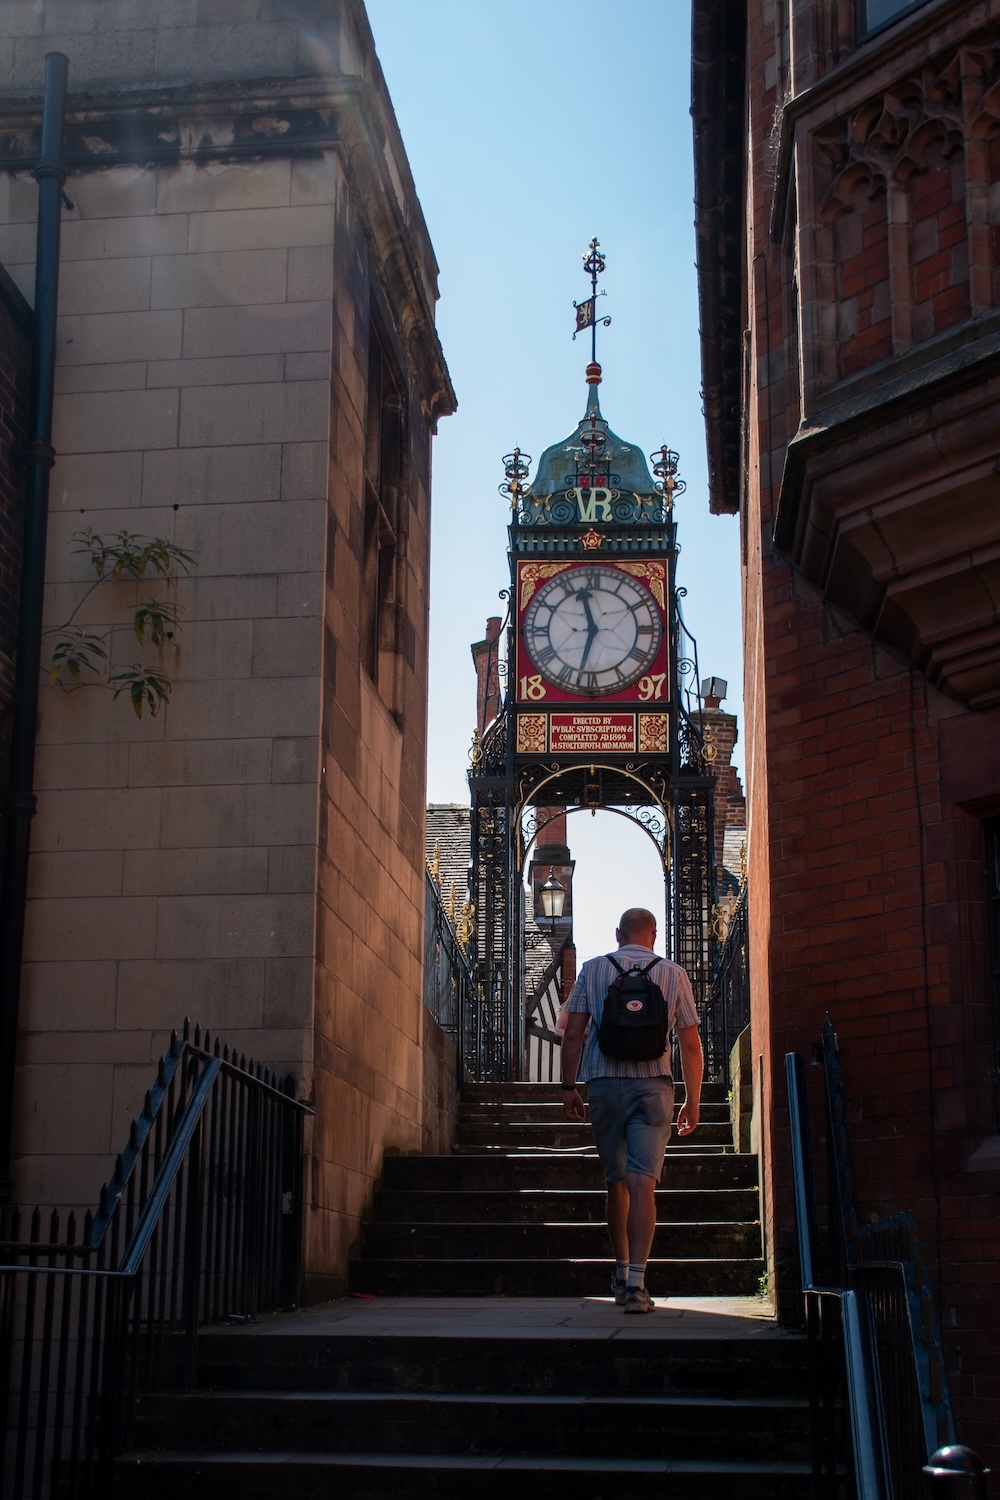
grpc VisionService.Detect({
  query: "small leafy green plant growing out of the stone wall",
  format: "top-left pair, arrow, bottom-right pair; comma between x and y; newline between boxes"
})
46,527 -> 196,719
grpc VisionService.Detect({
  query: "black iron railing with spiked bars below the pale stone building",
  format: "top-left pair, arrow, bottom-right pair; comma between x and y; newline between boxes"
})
0,1026 -> 309,1500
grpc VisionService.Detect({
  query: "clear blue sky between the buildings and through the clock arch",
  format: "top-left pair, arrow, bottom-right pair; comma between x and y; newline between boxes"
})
367,0 -> 742,957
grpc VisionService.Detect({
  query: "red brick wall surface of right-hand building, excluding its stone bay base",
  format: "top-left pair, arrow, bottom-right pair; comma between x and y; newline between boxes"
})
742,3 -> 1000,1493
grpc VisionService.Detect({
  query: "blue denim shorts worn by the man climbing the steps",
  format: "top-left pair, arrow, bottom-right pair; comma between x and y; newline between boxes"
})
586,1079 -> 673,1182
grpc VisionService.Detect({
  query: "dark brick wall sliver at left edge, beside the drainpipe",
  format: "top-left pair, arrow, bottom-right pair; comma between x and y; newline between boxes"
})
0,267 -> 31,791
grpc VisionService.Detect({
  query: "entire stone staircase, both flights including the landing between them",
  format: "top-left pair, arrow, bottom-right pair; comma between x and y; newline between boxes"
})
115,1085 -> 810,1500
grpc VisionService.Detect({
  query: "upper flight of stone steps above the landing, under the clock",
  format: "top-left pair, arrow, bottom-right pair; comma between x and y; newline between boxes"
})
351,1083 -> 763,1298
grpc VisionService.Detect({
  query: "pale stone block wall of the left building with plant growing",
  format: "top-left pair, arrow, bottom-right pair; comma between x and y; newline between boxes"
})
0,0 -> 454,1292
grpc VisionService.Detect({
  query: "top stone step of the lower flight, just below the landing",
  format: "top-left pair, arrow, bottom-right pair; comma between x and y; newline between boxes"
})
191,1332 -> 808,1401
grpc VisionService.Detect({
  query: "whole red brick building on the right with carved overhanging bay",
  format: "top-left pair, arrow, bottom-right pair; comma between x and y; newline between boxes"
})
693,0 -> 1000,1473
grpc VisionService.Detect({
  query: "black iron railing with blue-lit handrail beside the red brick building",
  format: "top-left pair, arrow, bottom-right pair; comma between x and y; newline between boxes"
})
786,1017 -> 985,1500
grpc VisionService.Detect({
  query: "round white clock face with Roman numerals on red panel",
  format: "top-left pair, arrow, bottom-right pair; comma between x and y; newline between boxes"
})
523,564 -> 663,698
